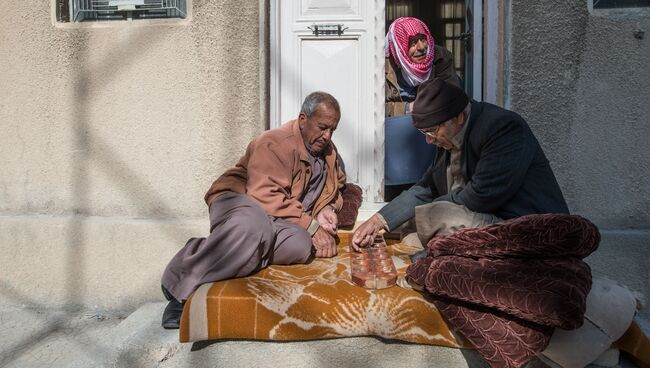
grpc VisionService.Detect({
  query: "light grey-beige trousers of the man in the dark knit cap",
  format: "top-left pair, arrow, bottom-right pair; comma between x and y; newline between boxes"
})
400,201 -> 501,248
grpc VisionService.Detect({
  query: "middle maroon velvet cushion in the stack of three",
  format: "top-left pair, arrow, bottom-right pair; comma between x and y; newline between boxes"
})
409,256 -> 591,330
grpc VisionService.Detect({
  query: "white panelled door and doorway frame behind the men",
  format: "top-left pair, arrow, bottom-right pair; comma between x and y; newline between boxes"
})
260,0 -> 494,210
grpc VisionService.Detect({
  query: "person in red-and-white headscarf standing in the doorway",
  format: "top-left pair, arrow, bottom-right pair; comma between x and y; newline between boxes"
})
384,17 -> 460,201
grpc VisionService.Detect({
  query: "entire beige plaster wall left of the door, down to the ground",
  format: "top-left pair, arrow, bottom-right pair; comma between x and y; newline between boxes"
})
0,0 -> 265,308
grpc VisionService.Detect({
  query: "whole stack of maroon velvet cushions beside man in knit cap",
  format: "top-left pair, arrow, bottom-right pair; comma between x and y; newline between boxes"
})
407,214 -> 600,367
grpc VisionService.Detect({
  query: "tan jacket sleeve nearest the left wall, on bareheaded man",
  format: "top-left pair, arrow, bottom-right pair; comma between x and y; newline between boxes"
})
246,140 -> 312,229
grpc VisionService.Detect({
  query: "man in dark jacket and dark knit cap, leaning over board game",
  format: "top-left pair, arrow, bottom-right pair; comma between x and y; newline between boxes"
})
352,79 -> 569,250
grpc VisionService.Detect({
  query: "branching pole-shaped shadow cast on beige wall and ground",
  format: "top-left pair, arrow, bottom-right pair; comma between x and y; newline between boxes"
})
0,25 -> 172,367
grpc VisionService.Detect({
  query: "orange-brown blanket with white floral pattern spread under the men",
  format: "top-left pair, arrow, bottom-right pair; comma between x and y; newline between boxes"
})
180,233 -> 469,347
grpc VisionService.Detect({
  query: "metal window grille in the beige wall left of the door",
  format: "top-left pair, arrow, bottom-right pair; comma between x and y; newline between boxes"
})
70,0 -> 187,22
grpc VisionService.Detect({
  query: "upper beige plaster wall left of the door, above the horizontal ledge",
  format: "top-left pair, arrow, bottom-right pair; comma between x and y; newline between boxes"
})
0,1 -> 263,218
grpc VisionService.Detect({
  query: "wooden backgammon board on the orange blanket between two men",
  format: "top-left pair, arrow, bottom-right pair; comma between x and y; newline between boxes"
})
350,235 -> 397,289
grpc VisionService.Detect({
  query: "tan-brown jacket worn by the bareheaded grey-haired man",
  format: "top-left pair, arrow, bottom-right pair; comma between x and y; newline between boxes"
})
205,120 -> 345,229
